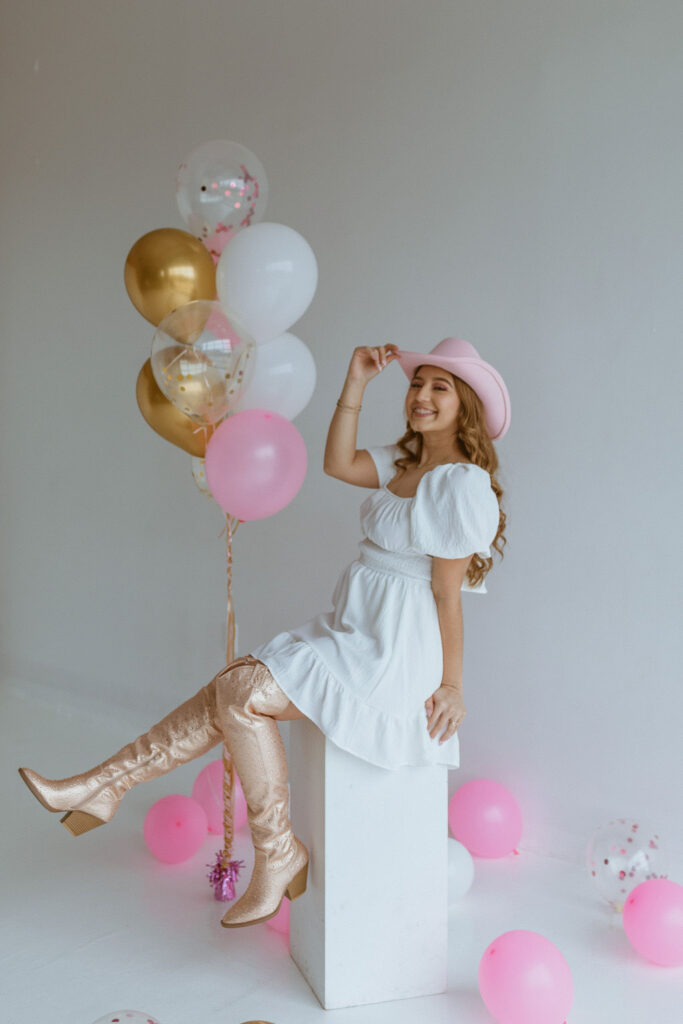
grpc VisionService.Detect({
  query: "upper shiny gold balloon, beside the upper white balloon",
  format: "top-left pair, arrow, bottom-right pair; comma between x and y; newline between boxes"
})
123,227 -> 216,325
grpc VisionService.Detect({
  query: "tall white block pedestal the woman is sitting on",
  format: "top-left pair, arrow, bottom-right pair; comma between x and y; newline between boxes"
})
289,720 -> 449,1010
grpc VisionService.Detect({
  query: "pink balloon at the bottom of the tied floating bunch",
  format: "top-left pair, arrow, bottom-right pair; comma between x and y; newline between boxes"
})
204,409 -> 307,521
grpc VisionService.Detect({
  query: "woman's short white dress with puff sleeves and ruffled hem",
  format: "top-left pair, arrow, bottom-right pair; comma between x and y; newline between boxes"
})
250,444 -> 499,769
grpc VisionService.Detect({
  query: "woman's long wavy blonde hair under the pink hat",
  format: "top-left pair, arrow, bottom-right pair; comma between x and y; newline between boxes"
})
393,368 -> 508,587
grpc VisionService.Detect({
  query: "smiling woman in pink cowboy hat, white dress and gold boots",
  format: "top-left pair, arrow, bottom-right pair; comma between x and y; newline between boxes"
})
19,338 -> 510,928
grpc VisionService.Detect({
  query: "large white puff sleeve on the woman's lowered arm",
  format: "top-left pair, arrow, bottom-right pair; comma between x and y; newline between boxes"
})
411,462 -> 500,558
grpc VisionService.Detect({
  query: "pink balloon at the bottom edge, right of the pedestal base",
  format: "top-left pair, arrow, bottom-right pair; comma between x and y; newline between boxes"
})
479,929 -> 573,1024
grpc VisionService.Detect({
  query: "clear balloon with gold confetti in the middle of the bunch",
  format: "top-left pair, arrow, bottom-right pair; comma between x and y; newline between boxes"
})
151,301 -> 256,426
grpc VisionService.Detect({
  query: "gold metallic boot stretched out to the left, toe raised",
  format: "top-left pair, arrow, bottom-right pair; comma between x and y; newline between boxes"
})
18,658 -> 255,836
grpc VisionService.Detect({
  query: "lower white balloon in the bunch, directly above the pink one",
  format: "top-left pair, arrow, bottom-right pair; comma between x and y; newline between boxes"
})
237,331 -> 317,420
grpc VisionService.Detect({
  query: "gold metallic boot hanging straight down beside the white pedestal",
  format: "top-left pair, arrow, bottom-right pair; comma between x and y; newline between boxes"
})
216,655 -> 308,928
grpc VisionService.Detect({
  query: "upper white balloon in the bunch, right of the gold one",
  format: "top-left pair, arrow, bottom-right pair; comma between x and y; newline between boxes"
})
216,222 -> 317,344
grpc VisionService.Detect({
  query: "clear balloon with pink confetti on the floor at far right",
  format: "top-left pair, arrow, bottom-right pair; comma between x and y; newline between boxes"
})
586,818 -> 667,913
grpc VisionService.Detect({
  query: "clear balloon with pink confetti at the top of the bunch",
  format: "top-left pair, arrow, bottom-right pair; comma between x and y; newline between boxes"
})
175,139 -> 268,263
